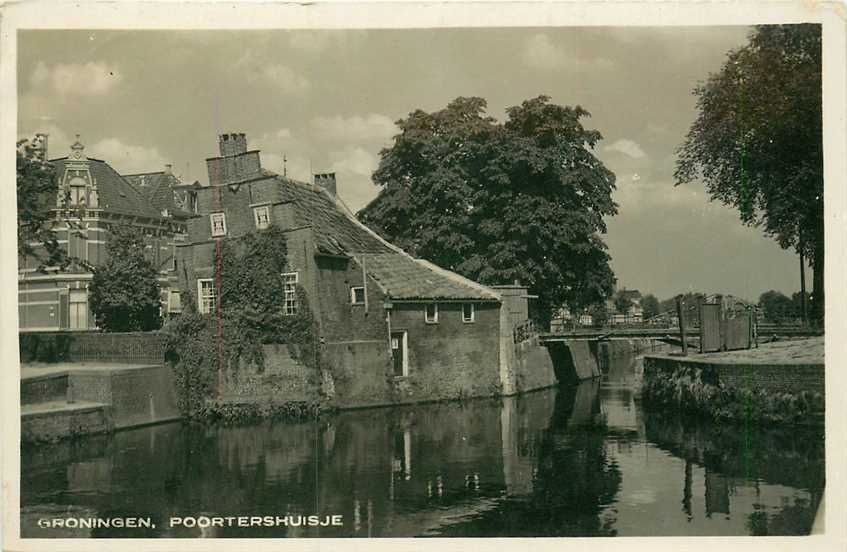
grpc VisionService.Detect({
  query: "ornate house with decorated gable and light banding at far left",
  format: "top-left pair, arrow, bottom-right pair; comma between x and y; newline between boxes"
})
18,135 -> 192,331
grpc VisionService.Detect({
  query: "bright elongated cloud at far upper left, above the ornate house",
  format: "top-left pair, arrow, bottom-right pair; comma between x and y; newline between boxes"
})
29,61 -> 123,96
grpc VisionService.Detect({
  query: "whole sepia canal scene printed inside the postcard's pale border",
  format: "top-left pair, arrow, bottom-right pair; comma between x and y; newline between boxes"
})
3,1 -> 844,550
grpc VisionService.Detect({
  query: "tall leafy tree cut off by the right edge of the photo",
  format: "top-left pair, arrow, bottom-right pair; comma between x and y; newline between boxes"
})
676,25 -> 824,323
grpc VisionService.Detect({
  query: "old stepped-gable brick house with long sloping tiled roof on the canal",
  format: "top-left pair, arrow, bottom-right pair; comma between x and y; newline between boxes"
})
176,134 -> 555,406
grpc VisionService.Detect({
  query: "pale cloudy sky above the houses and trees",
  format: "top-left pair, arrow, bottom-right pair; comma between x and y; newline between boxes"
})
18,27 -> 810,299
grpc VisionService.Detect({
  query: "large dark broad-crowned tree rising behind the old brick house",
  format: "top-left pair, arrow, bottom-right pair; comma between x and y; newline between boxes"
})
359,96 -> 617,321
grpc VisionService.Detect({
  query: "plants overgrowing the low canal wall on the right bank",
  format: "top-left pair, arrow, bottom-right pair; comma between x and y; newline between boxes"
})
641,366 -> 824,424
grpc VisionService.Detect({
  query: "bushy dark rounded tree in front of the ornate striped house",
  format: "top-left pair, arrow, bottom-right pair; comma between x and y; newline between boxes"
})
88,226 -> 162,332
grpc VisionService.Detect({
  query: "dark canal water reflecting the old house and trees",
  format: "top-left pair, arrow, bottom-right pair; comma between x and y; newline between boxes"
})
21,352 -> 824,537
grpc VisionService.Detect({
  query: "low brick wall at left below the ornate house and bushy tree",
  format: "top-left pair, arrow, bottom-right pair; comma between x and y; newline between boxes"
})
18,332 -> 165,364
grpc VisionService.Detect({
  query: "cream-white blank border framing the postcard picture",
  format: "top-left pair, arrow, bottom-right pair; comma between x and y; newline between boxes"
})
0,0 -> 847,552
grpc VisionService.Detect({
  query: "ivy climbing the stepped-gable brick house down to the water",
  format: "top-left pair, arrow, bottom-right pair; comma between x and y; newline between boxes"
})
165,227 -> 321,420
